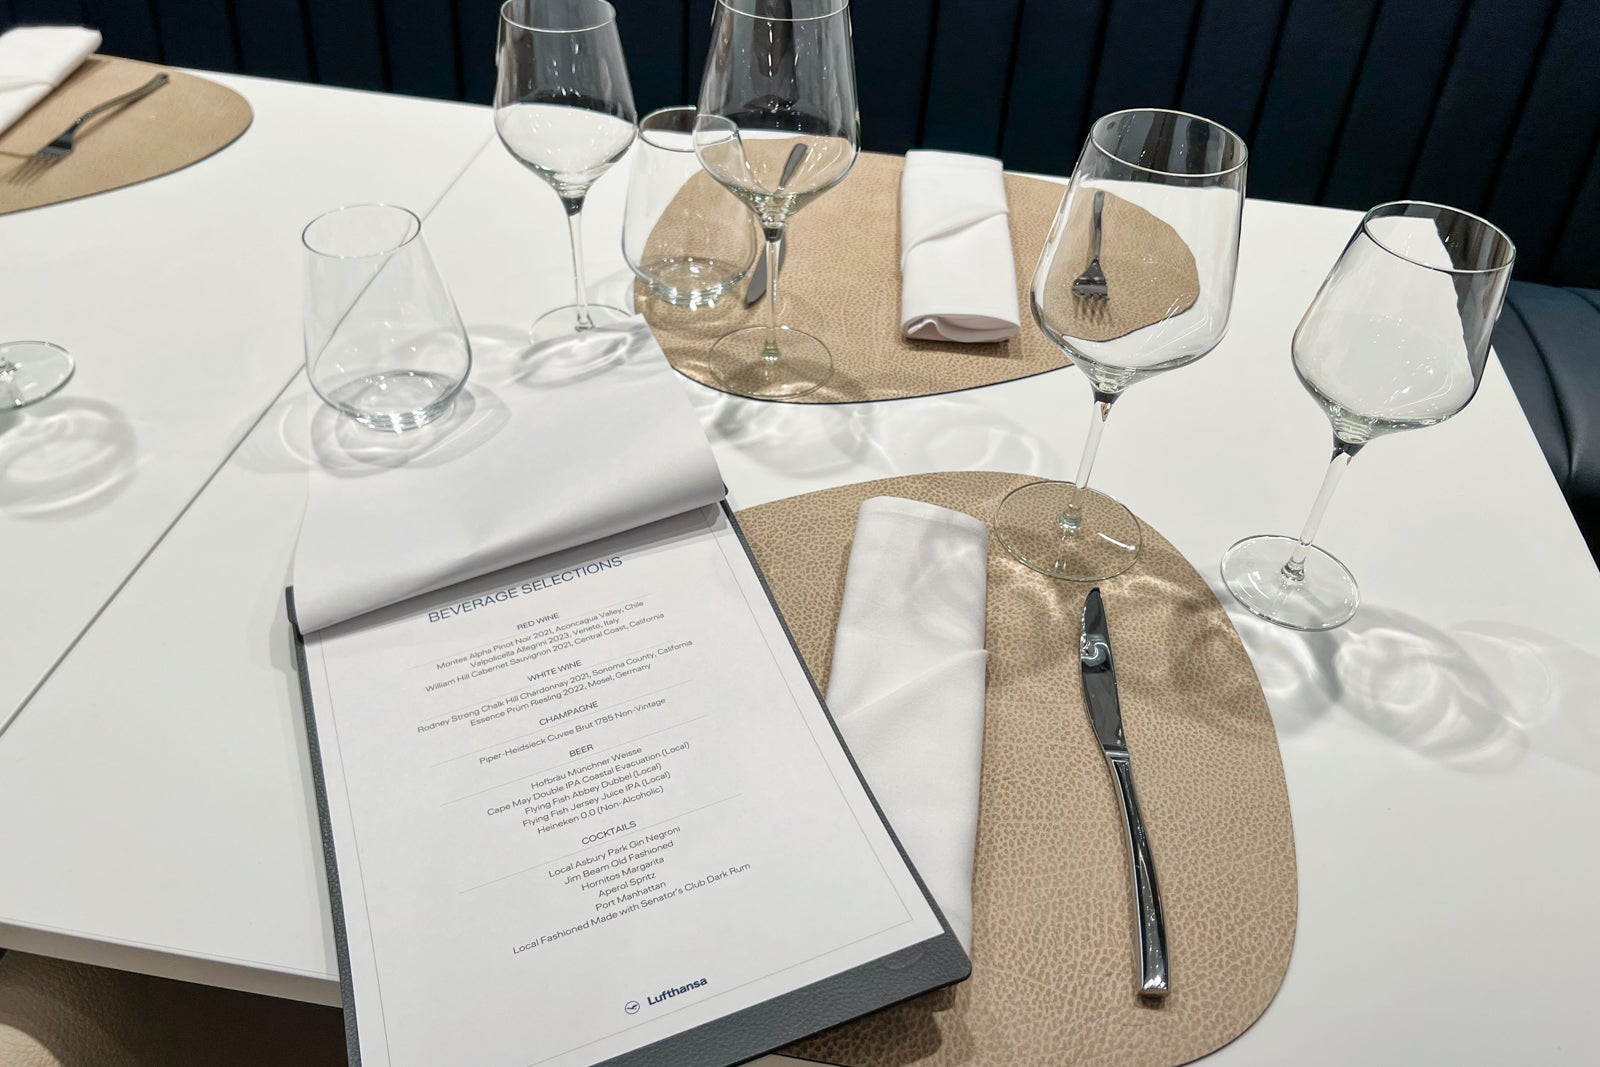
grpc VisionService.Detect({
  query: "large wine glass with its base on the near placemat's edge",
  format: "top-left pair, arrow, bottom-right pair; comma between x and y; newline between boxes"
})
994,109 -> 1248,581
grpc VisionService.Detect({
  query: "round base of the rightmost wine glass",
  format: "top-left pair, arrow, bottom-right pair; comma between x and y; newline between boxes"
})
1222,534 -> 1362,630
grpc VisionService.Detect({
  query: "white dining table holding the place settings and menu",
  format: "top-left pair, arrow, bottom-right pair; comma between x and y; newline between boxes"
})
0,78 -> 1600,1065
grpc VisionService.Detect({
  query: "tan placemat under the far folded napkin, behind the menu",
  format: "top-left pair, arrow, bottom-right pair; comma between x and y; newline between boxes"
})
634,152 -> 1070,403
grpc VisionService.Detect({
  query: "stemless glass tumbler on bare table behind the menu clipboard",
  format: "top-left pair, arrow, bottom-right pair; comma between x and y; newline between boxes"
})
301,203 -> 472,432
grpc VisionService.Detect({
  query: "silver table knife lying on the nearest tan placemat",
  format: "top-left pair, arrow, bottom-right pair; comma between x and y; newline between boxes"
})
1078,589 -> 1168,997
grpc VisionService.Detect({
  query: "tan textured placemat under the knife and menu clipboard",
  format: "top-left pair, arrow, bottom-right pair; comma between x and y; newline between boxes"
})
739,472 -> 1296,1067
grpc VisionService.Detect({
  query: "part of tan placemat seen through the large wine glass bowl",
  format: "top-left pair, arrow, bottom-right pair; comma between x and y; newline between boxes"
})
1043,192 -> 1200,341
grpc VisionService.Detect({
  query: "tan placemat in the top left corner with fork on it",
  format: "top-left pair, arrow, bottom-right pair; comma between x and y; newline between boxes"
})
0,56 -> 254,214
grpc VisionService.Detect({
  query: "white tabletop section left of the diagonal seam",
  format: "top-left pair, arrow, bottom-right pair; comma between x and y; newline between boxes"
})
0,77 -> 493,726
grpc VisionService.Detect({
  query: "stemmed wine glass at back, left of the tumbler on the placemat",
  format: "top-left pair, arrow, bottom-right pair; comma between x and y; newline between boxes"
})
494,0 -> 637,342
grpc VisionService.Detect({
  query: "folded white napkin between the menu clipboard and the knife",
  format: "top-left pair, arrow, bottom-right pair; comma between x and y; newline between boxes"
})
827,496 -> 989,952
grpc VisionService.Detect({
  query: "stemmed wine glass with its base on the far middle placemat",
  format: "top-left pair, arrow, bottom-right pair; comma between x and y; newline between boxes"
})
694,0 -> 861,398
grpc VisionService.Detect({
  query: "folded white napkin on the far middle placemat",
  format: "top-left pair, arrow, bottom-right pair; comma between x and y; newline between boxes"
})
901,150 -> 1021,342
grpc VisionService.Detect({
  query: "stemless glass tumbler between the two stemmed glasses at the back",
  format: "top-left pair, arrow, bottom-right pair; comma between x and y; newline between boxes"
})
622,107 -> 755,307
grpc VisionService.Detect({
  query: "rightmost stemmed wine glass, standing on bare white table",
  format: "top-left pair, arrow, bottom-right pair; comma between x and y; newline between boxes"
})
1222,200 -> 1517,630
